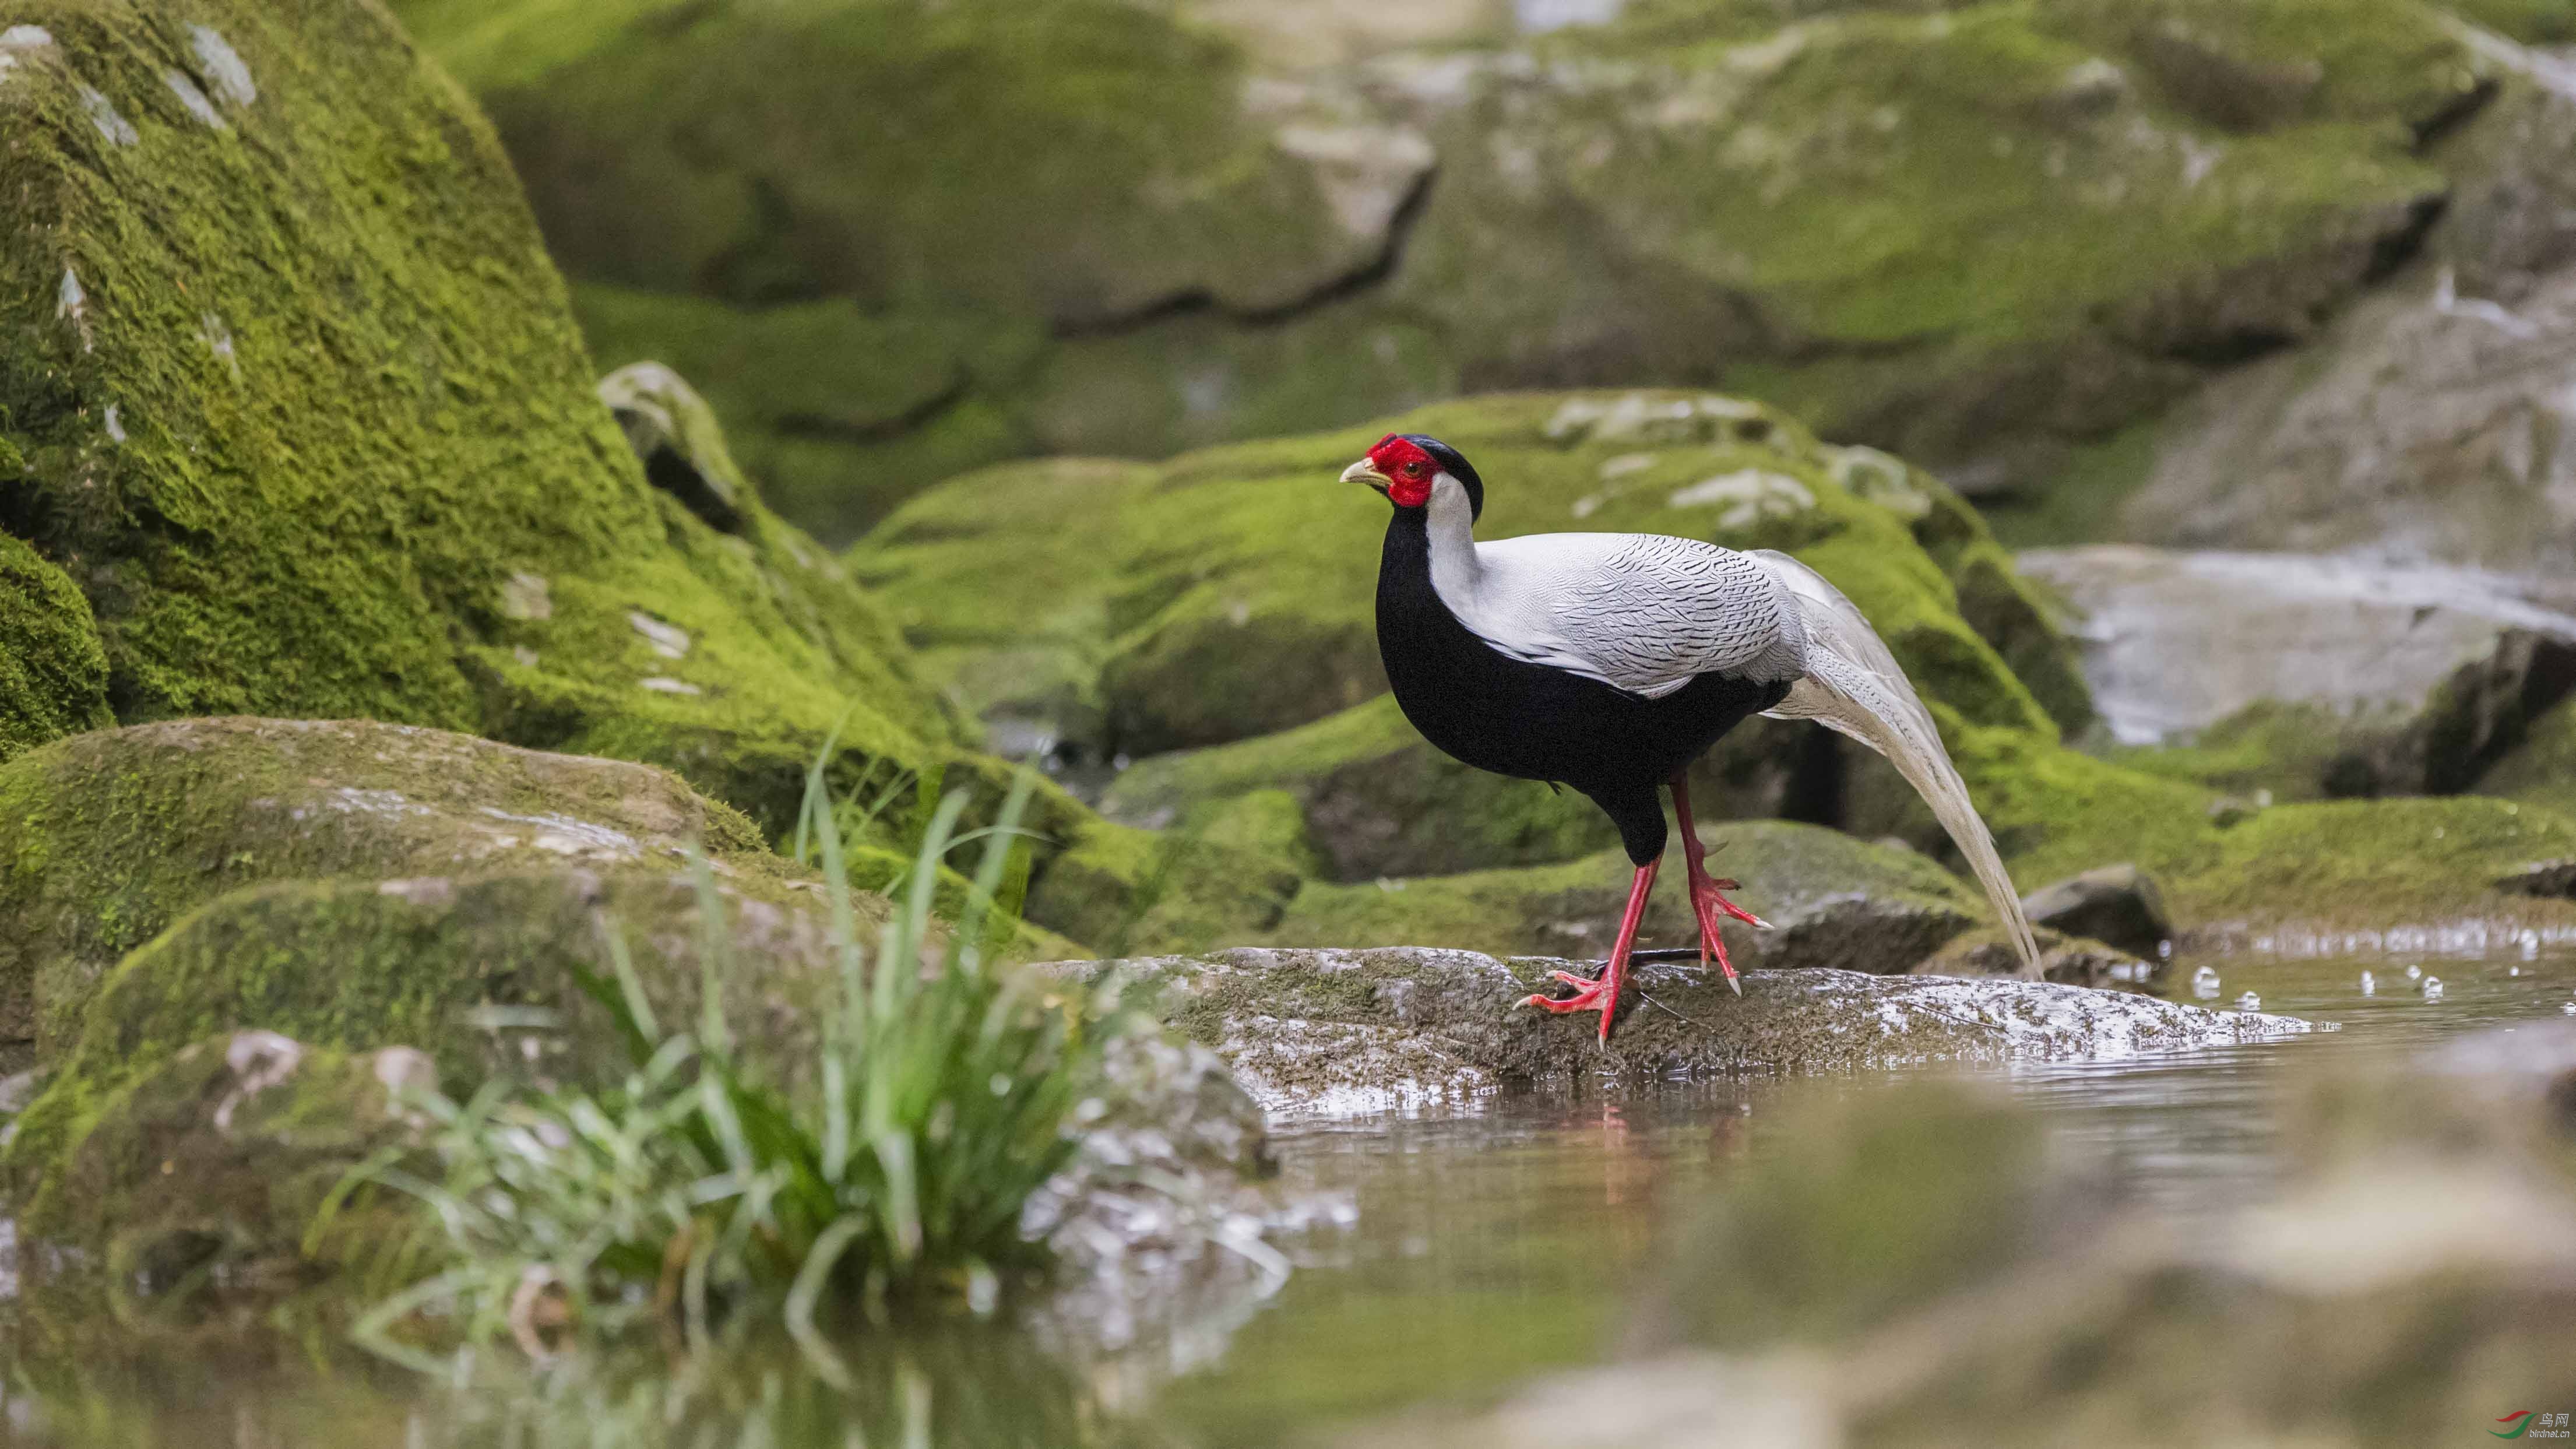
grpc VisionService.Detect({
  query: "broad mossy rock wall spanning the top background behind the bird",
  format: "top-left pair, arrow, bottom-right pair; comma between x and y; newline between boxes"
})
399,0 -> 2525,539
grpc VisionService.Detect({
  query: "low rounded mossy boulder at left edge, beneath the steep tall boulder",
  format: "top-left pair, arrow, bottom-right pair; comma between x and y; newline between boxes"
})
0,719 -> 789,1060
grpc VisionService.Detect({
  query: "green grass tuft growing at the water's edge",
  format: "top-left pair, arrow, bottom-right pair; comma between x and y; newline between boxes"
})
332,750 -> 1110,1377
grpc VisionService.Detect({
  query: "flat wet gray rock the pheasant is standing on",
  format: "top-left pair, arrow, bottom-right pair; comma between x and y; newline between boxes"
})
1046,946 -> 2308,1114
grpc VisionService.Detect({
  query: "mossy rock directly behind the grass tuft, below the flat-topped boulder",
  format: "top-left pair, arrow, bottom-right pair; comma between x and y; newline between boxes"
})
0,866 -> 884,1212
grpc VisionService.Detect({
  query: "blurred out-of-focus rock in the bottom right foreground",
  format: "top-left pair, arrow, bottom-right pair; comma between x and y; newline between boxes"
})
1339,1021 -> 2576,1449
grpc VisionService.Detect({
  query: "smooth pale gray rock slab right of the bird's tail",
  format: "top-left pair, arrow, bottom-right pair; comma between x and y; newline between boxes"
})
2017,544 -> 2576,794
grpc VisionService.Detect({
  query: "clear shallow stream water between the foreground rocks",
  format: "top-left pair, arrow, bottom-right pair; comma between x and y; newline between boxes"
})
0,954 -> 2576,1449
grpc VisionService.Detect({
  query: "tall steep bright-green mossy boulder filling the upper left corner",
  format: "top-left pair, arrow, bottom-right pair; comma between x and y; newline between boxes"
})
0,0 -> 951,828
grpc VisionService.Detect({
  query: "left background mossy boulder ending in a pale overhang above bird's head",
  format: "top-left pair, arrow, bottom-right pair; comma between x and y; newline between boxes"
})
397,0 -> 1433,534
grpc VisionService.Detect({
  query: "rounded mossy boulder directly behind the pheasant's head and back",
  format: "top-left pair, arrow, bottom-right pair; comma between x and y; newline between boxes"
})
850,392 -> 2089,755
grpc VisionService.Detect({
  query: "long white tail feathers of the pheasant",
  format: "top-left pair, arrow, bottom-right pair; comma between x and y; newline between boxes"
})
1754,549 -> 2040,980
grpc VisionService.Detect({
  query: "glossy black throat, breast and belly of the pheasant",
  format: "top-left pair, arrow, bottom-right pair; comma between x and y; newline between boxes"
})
1378,511 -> 1787,864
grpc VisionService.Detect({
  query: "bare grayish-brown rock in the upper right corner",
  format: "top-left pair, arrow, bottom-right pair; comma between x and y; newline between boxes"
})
2120,62 -> 2576,572
